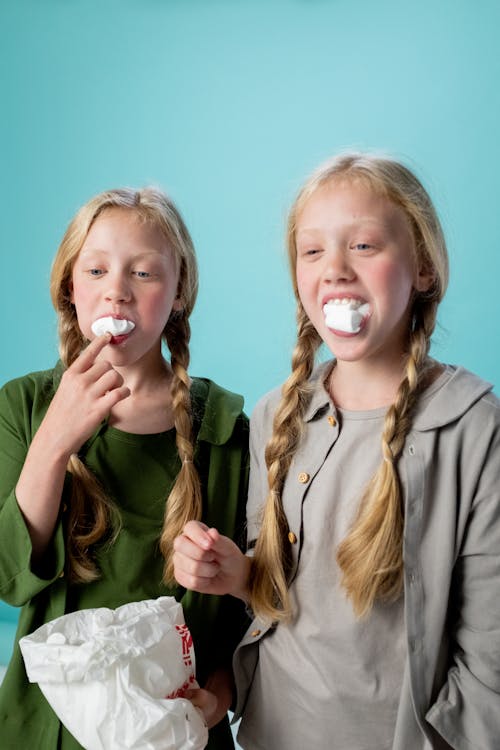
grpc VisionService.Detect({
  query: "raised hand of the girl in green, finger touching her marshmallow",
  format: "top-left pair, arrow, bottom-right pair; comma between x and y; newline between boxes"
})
40,333 -> 130,459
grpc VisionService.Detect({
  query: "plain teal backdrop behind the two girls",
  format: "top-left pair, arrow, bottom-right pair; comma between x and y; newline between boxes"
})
0,0 -> 500,661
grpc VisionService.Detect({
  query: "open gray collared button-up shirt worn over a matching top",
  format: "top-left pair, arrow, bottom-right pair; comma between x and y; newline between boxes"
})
234,364 -> 500,750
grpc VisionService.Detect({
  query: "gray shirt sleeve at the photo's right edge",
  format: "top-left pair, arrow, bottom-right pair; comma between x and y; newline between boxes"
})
426,408 -> 500,750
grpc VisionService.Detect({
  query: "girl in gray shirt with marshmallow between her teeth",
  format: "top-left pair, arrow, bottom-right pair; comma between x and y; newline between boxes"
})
174,154 -> 500,750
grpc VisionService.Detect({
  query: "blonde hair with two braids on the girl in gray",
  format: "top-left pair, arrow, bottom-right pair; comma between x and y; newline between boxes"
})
250,153 -> 448,620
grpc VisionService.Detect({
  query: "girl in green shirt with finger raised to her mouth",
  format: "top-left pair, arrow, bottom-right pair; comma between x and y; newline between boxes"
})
0,188 -> 248,750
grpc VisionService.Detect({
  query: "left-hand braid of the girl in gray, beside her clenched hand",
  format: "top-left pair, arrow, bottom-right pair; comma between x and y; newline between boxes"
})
250,303 -> 321,620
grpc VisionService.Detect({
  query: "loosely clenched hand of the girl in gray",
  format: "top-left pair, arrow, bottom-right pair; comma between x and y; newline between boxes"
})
173,521 -> 250,601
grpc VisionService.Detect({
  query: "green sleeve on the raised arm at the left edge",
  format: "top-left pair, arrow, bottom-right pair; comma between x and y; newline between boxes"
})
0,381 -> 65,606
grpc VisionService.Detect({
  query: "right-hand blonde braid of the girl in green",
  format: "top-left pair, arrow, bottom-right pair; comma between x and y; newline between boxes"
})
160,313 -> 202,583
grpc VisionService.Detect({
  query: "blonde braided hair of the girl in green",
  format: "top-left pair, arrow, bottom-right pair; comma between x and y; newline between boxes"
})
50,187 -> 202,583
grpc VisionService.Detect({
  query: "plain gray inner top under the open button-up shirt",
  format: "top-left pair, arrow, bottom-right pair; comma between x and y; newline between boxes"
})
239,406 -> 408,750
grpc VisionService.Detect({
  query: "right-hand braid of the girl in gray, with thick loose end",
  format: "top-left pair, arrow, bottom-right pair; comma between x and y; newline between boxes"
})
337,305 -> 435,616
